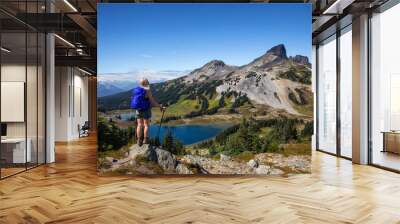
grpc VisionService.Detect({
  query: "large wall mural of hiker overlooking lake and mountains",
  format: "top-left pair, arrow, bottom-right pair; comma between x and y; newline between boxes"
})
97,4 -> 313,176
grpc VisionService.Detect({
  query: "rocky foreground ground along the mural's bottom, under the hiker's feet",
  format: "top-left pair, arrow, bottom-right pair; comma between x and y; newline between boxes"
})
99,145 -> 311,175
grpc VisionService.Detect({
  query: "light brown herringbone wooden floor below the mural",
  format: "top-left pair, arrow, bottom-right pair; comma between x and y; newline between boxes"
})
0,138 -> 400,224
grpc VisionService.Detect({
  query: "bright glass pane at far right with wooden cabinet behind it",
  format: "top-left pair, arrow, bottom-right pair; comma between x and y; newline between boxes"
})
370,4 -> 400,171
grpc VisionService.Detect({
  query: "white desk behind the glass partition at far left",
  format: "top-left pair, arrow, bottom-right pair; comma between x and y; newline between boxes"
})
1,138 -> 32,163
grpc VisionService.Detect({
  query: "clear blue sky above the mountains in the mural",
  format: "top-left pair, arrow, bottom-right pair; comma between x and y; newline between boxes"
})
97,3 -> 311,74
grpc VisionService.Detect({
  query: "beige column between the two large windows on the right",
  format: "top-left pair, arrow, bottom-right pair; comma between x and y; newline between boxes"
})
352,15 -> 368,164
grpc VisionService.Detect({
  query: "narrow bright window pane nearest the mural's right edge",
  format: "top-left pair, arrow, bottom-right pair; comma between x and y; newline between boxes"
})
317,35 -> 337,154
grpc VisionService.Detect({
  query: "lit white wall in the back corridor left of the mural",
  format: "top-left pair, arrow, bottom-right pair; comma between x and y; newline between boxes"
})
55,67 -> 89,141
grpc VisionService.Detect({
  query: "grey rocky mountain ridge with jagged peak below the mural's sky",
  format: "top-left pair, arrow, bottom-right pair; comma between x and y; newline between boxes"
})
99,44 -> 312,115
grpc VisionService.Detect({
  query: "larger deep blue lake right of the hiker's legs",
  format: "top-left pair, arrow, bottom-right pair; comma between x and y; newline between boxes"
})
150,124 -> 231,145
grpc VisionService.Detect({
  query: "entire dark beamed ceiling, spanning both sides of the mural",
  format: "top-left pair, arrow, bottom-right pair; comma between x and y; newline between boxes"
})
0,0 -> 386,74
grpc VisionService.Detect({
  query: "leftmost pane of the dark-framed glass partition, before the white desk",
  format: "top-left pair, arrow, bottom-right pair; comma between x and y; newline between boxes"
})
0,32 -> 27,177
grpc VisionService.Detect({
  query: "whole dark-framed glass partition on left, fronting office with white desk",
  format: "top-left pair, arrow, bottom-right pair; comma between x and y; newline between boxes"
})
0,1 -> 46,179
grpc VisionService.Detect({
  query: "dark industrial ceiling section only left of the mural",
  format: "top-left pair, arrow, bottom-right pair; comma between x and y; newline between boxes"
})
0,0 -> 98,74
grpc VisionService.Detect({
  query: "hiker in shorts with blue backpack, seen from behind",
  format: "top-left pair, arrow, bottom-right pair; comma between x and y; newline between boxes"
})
131,78 -> 165,146
